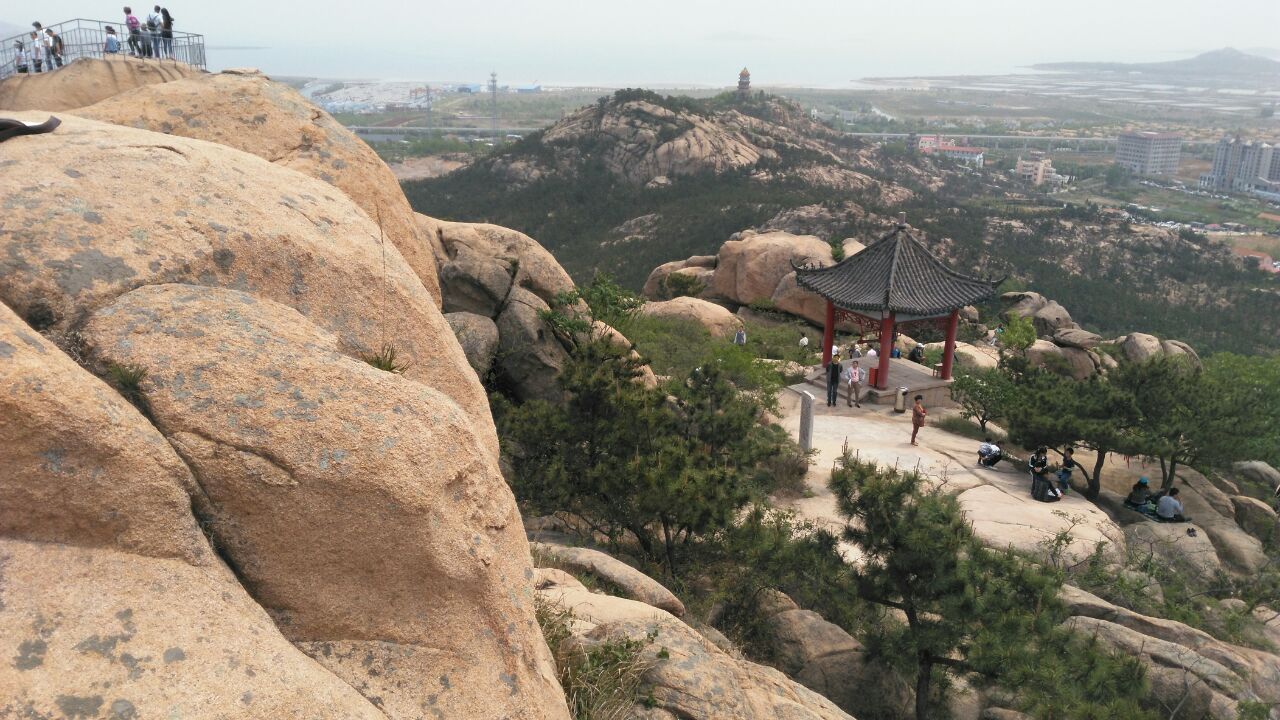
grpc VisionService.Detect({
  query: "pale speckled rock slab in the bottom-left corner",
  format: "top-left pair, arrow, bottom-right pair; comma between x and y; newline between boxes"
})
0,535 -> 389,720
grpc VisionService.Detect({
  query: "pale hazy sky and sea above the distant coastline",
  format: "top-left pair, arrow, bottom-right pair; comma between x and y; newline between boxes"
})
10,0 -> 1280,87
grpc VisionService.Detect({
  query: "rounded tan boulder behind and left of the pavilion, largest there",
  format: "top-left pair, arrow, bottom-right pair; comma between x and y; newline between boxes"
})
714,231 -> 835,305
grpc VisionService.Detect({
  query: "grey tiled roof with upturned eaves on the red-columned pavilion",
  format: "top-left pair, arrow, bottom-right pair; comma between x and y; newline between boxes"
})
796,224 -> 1000,316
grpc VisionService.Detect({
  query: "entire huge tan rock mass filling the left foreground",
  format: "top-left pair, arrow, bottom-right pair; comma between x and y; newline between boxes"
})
0,70 -> 567,719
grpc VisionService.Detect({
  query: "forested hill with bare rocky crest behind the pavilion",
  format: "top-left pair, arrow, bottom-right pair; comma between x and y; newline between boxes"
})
404,90 -> 1280,352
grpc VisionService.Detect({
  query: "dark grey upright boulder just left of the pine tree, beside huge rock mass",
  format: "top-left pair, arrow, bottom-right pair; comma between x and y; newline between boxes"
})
498,287 -> 568,402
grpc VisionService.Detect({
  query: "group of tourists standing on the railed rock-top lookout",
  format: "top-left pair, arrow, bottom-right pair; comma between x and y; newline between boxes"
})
13,5 -> 175,74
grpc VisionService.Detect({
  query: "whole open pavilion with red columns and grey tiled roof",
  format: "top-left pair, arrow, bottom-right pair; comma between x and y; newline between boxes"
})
796,215 -> 1000,389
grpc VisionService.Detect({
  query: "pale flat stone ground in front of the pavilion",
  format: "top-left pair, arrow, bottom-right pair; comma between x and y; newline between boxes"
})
778,384 -> 1124,557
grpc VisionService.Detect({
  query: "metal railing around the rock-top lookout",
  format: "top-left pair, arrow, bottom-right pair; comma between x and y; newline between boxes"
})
0,18 -> 206,79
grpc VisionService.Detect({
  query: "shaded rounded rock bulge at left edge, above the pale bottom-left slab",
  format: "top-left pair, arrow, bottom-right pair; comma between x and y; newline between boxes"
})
0,299 -> 214,563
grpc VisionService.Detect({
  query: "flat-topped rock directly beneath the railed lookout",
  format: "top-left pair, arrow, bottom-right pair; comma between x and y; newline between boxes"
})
0,55 -> 201,110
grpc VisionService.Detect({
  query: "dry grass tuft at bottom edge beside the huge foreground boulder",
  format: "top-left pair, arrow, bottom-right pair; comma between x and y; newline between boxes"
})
535,598 -> 657,720
